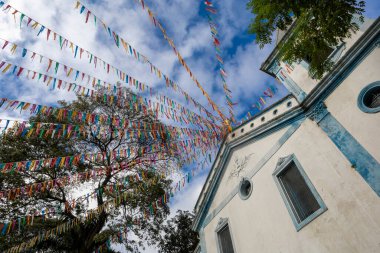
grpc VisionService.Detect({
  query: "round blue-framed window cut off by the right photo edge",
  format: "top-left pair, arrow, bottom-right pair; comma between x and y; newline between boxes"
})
358,81 -> 380,113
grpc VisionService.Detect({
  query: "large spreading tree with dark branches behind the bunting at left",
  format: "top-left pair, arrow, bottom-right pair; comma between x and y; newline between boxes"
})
0,90 -> 181,252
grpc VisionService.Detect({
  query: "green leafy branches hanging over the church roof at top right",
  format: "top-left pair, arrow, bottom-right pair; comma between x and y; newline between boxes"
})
247,0 -> 365,79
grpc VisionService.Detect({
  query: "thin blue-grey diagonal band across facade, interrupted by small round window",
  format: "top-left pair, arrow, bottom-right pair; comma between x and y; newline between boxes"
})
200,119 -> 304,228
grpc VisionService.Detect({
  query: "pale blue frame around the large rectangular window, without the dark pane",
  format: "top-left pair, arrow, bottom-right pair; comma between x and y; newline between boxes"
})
272,154 -> 327,232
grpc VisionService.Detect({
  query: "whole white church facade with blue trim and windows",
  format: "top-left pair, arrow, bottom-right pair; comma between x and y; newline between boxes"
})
193,18 -> 380,253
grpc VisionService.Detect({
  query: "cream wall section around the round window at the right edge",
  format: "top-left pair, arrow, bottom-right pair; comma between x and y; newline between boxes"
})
325,47 -> 380,162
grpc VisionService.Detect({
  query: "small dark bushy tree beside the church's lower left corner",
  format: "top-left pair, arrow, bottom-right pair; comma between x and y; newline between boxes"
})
158,210 -> 199,253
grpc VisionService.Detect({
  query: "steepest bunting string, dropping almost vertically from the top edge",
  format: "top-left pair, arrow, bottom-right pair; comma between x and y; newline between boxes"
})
204,1 -> 236,121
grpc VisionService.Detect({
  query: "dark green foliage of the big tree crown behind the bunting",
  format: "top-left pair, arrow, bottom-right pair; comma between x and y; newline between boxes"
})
0,93 -> 177,252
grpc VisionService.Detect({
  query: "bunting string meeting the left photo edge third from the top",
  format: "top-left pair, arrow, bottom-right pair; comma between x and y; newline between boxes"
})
0,61 -> 212,129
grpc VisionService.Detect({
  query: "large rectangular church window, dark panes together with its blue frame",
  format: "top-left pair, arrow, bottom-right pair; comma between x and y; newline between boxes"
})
273,154 -> 327,231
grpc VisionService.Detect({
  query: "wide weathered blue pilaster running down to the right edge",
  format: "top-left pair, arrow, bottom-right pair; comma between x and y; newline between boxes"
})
319,113 -> 380,196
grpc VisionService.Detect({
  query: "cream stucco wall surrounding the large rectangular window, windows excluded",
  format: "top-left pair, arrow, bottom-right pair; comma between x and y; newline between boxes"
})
204,119 -> 380,253
